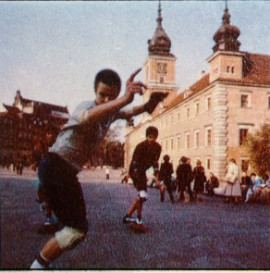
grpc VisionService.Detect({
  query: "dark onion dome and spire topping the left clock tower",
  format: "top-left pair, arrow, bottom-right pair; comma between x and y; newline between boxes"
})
148,2 -> 173,56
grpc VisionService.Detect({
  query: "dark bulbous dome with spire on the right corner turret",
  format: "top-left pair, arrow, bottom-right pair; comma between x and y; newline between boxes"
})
213,2 -> 241,52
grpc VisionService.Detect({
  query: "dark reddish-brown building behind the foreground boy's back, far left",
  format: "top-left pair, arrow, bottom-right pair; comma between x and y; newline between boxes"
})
0,90 -> 69,164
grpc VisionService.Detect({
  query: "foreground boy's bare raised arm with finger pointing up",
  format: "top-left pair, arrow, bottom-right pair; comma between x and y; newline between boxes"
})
83,68 -> 146,122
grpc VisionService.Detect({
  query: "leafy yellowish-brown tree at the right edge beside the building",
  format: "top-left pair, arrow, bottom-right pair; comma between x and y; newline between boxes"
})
244,124 -> 270,176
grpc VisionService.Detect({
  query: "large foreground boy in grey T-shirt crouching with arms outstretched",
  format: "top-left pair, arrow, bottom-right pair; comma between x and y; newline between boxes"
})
31,69 -> 167,269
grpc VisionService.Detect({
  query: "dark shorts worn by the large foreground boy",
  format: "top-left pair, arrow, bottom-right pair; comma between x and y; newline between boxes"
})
38,153 -> 88,232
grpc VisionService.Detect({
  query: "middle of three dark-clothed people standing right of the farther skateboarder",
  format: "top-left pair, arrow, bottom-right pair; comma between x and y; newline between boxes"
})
176,156 -> 193,203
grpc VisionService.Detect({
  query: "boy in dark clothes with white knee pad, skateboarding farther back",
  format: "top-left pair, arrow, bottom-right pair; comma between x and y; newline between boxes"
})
123,126 -> 161,232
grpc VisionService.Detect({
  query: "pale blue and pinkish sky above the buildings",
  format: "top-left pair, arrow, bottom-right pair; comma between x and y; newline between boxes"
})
0,1 -> 270,113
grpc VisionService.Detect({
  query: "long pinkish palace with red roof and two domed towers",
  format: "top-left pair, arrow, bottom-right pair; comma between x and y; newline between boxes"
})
125,3 -> 270,179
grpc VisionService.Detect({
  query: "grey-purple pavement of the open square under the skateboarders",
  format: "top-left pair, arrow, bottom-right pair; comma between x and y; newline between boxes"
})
0,169 -> 270,269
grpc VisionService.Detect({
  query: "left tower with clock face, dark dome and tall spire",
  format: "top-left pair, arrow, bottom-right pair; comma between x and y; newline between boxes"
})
143,2 -> 178,109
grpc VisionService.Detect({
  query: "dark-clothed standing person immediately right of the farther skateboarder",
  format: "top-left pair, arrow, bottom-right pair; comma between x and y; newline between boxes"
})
159,154 -> 174,203
